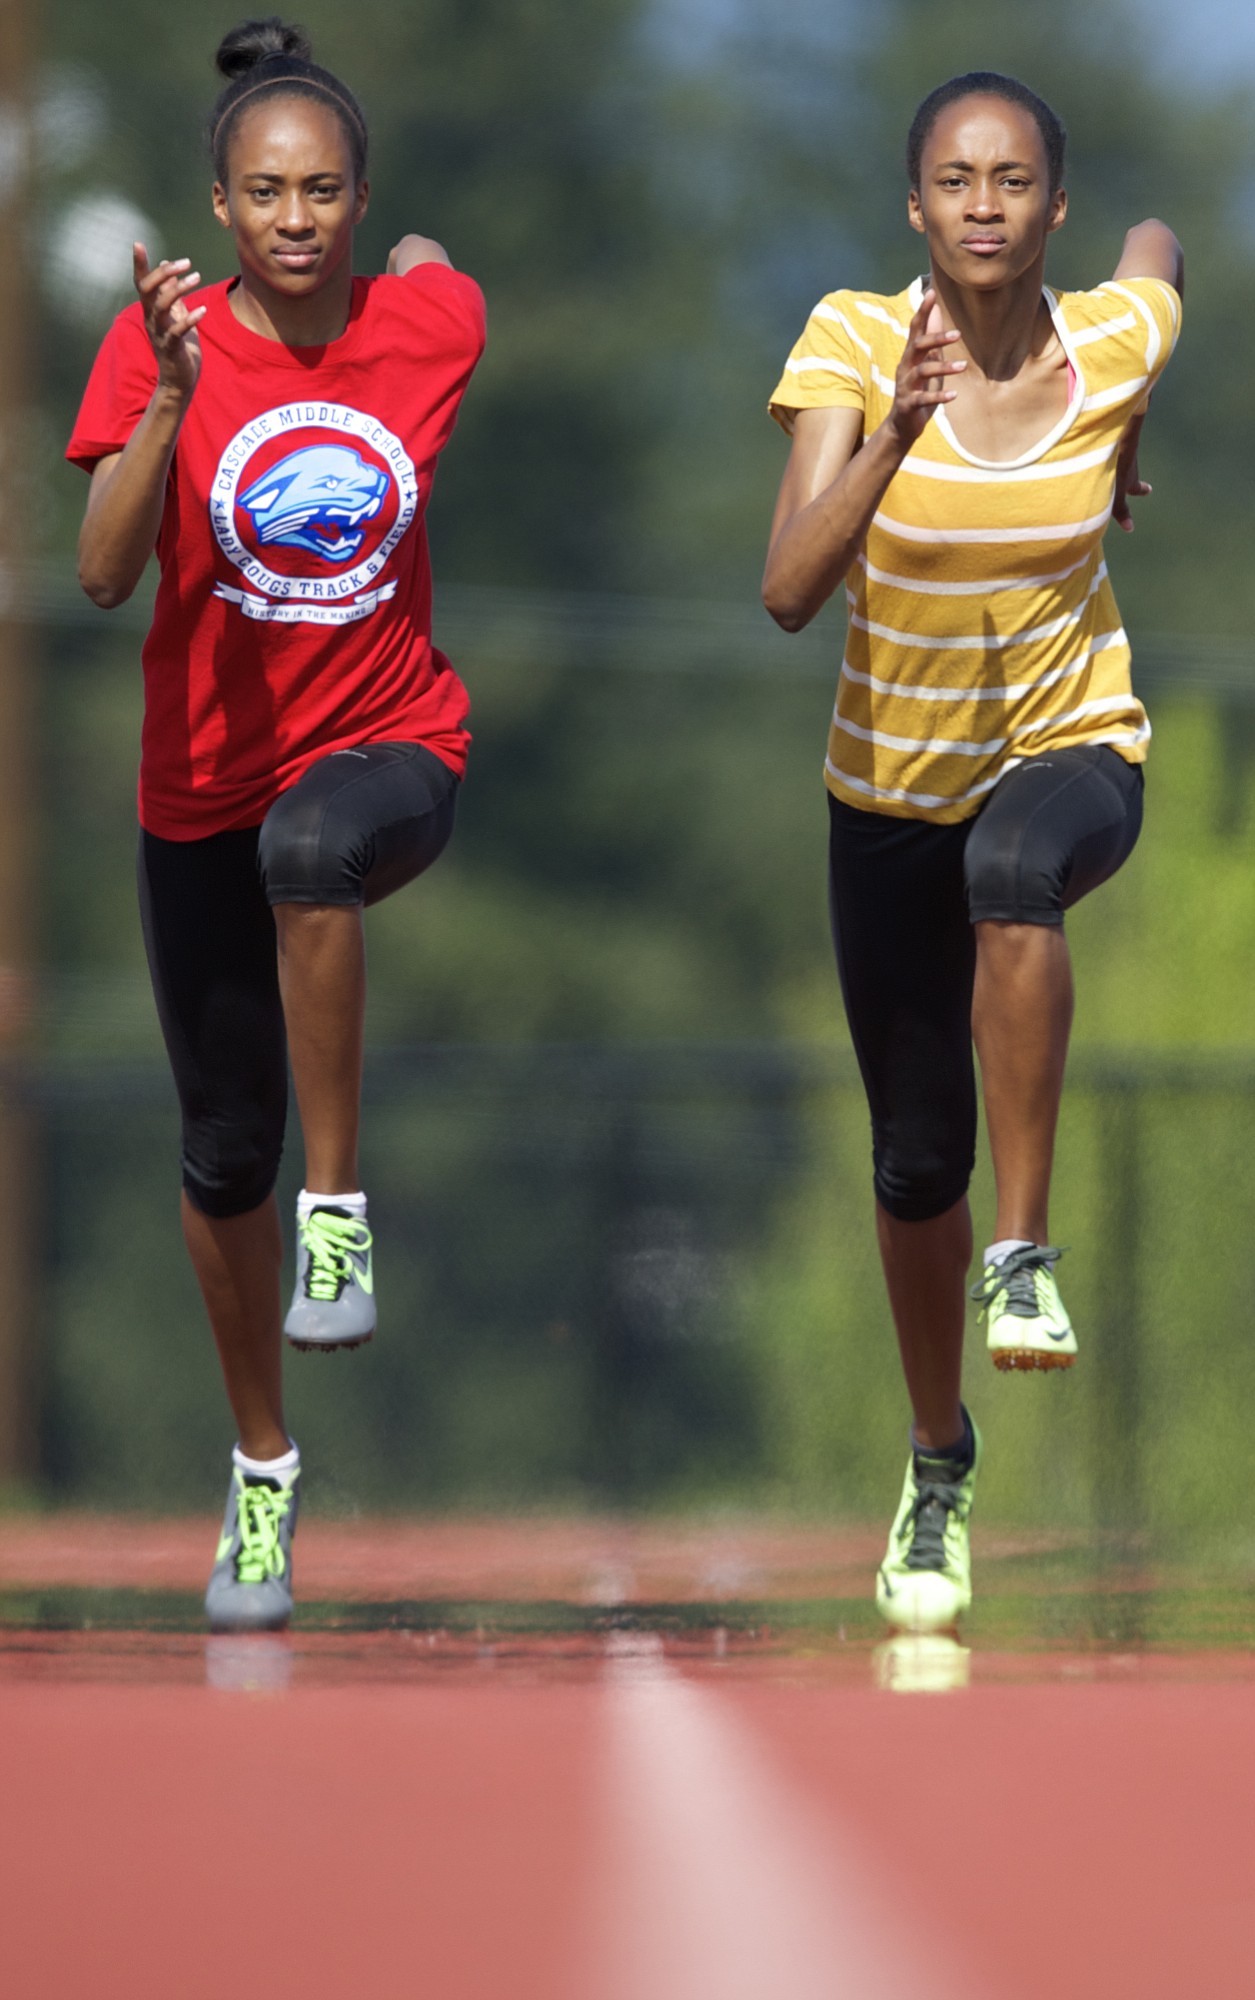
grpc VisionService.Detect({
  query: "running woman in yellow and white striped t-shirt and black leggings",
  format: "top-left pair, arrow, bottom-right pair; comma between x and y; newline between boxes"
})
763,72 -> 1183,1630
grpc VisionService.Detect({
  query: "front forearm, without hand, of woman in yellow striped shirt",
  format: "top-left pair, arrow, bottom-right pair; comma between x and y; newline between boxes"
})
763,422 -> 909,632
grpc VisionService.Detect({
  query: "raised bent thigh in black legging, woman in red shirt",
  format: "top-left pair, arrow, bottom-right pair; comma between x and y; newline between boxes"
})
258,744 -> 458,908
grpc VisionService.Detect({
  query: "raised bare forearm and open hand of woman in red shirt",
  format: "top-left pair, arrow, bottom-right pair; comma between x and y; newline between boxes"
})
78,244 -> 204,610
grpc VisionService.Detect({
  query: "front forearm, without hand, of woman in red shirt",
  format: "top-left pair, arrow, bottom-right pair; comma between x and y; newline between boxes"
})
78,386 -> 188,610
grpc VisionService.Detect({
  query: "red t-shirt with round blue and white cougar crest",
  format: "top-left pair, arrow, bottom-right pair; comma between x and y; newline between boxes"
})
66,264 -> 484,840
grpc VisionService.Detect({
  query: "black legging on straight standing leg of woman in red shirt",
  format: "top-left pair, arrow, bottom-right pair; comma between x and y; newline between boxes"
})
138,828 -> 288,1214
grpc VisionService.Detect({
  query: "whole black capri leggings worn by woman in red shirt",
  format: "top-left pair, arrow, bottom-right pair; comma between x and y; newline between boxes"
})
140,744 -> 458,1216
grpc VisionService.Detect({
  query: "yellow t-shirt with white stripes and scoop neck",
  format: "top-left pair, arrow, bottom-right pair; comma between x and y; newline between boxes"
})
771,278 -> 1181,820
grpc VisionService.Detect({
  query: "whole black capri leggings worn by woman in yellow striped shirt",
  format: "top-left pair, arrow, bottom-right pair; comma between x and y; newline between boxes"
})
827,746 -> 1143,1222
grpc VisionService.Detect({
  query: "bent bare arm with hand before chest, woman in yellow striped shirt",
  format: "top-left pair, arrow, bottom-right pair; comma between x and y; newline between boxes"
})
763,290 -> 967,632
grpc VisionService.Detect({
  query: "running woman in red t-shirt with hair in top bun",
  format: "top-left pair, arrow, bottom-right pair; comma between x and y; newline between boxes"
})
68,18 -> 484,1630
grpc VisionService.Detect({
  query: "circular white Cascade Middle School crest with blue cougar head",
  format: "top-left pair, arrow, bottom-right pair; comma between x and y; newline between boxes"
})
210,402 -> 418,624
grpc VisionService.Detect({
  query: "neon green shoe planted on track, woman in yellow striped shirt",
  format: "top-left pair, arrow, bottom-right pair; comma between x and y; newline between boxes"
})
875,1418 -> 981,1632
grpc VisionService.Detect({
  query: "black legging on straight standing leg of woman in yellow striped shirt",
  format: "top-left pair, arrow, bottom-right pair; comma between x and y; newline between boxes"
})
829,800 -> 975,1220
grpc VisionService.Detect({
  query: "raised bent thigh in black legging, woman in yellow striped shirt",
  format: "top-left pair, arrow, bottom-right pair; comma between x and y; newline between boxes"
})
967,744 -> 1143,926
